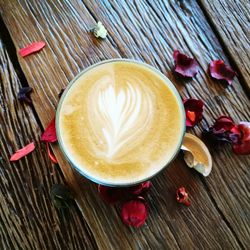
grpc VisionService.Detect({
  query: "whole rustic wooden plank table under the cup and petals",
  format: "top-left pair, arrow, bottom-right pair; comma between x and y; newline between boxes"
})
0,0 -> 250,249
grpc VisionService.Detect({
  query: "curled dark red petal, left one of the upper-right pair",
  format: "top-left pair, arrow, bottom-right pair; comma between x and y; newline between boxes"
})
173,50 -> 199,77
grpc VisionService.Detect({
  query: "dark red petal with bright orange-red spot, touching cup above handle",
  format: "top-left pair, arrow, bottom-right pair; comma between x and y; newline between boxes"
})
183,98 -> 204,127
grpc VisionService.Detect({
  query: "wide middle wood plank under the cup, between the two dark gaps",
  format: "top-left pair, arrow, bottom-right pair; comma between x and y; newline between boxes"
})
1,0 -> 250,249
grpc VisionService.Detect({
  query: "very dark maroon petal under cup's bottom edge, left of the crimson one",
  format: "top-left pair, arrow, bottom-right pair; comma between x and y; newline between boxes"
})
98,185 -> 123,204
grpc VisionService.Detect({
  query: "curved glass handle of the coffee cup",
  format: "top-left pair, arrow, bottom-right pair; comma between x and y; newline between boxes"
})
181,133 -> 212,176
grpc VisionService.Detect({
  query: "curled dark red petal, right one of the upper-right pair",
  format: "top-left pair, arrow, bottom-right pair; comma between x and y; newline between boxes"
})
210,60 -> 237,84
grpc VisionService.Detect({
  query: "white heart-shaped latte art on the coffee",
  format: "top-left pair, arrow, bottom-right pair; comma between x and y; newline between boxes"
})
88,76 -> 154,163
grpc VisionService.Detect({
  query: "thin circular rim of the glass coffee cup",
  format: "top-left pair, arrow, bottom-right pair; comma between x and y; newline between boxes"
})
56,58 -> 186,187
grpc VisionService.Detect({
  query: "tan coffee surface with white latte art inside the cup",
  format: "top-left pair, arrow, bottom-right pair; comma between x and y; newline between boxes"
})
59,61 -> 184,184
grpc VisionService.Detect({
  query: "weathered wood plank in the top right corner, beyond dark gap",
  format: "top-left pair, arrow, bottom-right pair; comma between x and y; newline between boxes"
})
199,0 -> 250,92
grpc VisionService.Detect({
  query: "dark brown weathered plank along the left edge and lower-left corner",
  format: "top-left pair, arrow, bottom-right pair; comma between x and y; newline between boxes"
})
0,38 -> 95,250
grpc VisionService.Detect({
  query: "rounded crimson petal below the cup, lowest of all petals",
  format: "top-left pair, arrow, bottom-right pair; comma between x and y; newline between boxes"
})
121,197 -> 148,227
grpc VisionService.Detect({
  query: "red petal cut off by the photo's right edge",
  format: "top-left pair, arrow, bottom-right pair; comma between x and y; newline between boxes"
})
233,122 -> 250,155
